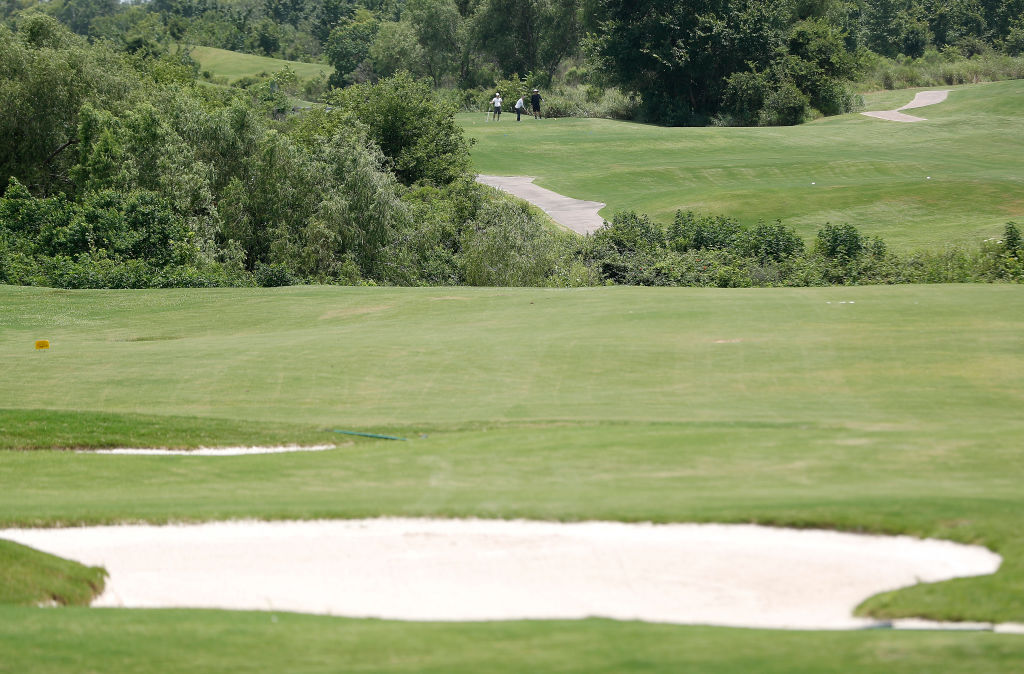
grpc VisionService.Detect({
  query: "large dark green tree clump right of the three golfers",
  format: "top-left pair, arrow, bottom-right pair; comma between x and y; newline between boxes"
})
591,0 -> 858,124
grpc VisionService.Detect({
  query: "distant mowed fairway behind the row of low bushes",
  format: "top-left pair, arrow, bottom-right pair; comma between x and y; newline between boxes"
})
460,81 -> 1024,250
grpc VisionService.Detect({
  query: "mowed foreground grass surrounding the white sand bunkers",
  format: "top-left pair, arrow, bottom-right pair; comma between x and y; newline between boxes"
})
0,285 -> 1024,672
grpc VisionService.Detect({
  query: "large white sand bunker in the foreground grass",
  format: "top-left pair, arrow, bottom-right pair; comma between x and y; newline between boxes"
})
0,519 -> 1001,629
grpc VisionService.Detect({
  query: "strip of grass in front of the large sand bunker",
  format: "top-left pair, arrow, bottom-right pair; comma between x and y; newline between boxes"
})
0,606 -> 1024,674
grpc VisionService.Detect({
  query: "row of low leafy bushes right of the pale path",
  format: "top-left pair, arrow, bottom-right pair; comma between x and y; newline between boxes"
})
584,211 -> 1024,288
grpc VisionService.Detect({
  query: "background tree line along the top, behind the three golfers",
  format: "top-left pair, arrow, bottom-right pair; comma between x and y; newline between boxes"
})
0,0 -> 1024,124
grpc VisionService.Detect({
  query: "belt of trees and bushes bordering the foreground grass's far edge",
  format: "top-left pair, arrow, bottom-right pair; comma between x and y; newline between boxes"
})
0,12 -> 1024,288
